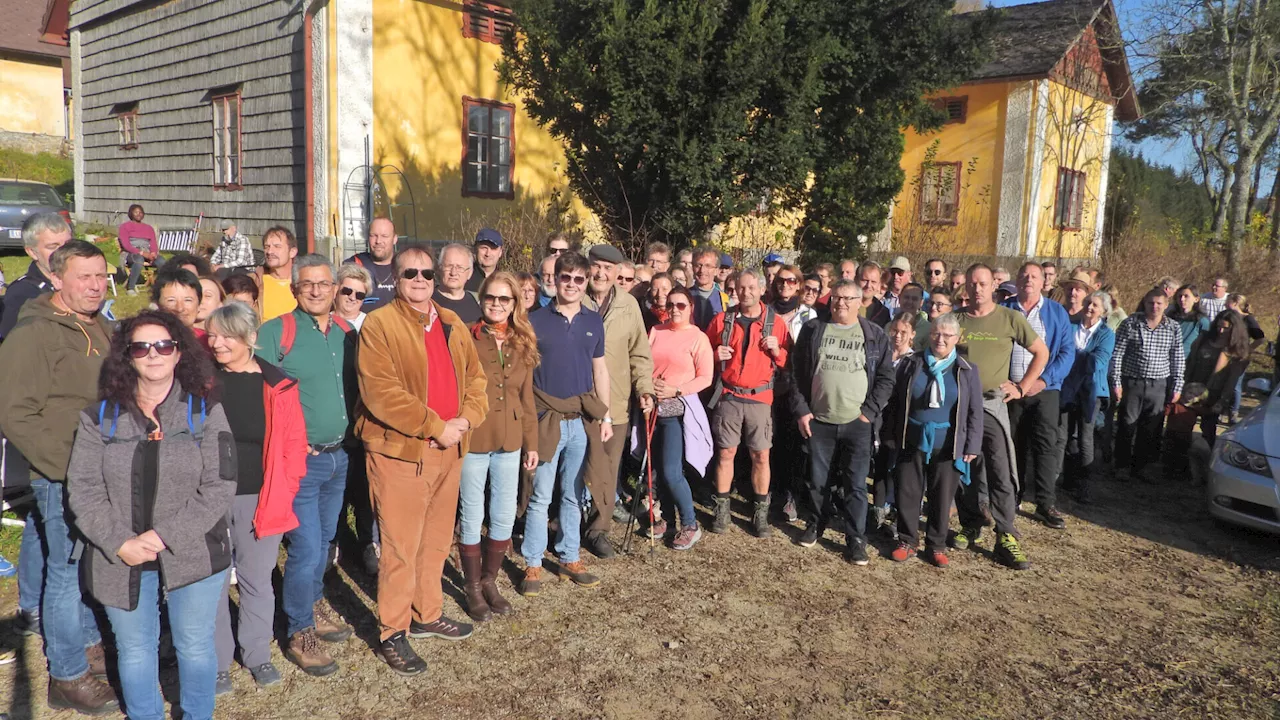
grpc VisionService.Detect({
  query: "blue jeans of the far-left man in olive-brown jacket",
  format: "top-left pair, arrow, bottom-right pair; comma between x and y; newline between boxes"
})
31,478 -> 102,680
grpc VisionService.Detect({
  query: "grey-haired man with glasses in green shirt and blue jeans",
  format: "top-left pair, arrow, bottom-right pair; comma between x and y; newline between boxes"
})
257,254 -> 367,676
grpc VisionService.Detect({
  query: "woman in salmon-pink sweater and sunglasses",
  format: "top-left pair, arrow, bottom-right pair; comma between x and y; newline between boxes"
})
649,287 -> 714,550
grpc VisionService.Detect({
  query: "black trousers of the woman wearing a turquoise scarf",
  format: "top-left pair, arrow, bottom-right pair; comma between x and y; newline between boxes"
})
893,450 -> 960,551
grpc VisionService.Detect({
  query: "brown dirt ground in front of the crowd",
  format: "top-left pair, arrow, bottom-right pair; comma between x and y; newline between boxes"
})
0,468 -> 1280,720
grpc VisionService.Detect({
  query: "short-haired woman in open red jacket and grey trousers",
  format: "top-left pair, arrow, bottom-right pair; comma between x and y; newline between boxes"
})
206,302 -> 307,694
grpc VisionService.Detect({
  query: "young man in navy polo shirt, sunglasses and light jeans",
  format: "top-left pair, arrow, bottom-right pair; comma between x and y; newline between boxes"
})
518,252 -> 613,597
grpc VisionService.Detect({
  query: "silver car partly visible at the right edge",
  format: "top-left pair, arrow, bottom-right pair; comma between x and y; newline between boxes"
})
1208,391 -> 1280,534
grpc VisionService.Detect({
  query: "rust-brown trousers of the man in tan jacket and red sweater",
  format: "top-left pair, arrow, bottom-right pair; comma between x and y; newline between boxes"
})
367,446 -> 462,639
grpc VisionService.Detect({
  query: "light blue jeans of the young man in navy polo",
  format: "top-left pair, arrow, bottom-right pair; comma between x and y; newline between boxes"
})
520,419 -> 586,568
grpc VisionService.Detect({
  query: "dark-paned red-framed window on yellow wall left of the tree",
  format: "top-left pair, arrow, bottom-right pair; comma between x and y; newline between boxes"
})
462,97 -> 516,200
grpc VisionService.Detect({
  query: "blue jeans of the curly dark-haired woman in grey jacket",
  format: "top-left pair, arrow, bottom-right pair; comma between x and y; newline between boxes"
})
106,570 -> 227,720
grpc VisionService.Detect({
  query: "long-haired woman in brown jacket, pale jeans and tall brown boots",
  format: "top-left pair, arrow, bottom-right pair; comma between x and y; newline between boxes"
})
458,272 -> 540,621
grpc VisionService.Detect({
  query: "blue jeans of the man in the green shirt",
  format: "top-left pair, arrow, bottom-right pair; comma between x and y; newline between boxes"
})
282,448 -> 347,635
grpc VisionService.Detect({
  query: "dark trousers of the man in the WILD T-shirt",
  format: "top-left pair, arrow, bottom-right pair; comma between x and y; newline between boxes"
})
806,420 -> 872,539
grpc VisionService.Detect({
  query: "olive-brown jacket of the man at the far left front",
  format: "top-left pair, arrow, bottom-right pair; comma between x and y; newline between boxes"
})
0,295 -> 113,482
